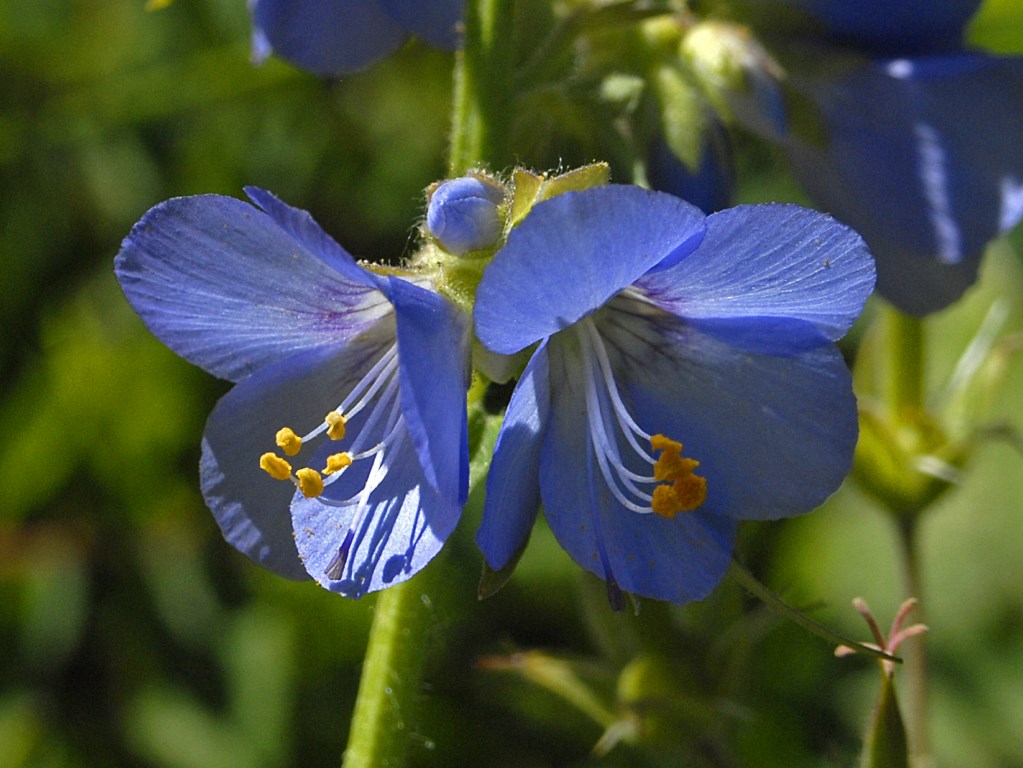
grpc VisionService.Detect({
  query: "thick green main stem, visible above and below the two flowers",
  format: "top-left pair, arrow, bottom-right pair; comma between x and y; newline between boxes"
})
344,0 -> 515,768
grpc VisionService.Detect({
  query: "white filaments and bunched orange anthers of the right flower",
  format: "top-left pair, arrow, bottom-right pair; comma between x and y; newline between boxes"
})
578,318 -> 707,518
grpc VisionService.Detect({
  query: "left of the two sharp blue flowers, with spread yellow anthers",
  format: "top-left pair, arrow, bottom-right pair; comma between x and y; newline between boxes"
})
115,188 -> 468,597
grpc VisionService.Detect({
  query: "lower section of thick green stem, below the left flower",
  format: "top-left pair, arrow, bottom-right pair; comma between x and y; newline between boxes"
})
343,563 -> 441,768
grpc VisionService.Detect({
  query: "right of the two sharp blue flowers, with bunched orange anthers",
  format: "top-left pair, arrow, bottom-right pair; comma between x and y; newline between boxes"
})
475,186 -> 874,605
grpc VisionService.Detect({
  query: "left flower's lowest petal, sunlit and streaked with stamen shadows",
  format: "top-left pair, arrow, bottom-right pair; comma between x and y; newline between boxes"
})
292,429 -> 461,598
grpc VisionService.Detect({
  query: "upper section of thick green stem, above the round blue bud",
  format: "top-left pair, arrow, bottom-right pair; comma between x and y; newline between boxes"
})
448,0 -> 515,176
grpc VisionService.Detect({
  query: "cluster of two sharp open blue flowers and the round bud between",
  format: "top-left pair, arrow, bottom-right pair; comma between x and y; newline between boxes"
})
116,177 -> 874,606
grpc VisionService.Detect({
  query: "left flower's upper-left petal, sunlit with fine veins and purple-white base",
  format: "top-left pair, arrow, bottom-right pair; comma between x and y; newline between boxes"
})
115,195 -> 390,380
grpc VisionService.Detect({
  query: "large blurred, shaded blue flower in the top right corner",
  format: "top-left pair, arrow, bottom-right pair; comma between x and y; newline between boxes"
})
736,0 -> 1023,315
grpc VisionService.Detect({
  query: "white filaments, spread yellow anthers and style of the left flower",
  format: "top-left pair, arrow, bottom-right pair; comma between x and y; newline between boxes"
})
259,345 -> 406,580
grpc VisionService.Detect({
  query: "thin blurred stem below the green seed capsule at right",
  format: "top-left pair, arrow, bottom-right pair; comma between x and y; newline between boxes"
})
896,514 -> 933,768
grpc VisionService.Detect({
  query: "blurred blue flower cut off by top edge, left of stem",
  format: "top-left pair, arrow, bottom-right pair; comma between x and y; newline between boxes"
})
250,0 -> 464,75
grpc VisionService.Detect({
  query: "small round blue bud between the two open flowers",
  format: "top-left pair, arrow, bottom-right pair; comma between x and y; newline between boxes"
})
427,176 -> 504,256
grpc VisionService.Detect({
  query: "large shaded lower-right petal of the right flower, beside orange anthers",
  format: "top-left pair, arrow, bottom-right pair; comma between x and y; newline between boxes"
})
601,312 -> 858,519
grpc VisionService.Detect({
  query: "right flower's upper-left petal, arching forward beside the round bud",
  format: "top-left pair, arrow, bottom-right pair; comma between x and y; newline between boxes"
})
475,185 -> 704,354
